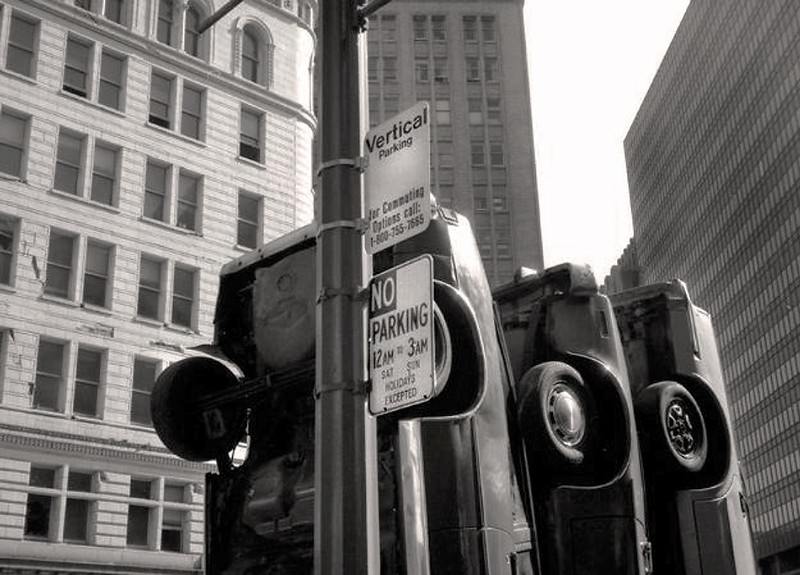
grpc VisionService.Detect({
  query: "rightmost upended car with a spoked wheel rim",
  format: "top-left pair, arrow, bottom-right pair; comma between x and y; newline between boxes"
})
611,280 -> 756,575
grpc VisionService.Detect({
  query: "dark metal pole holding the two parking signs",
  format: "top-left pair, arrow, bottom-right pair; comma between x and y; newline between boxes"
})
314,0 -> 379,575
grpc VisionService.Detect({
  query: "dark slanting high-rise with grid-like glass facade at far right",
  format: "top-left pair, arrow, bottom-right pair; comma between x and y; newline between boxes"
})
625,0 -> 800,573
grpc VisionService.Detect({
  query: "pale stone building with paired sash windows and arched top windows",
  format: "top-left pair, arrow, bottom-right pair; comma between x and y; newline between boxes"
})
0,0 -> 316,574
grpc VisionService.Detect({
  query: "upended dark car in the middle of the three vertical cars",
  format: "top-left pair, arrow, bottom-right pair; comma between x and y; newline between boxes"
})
494,264 -> 650,575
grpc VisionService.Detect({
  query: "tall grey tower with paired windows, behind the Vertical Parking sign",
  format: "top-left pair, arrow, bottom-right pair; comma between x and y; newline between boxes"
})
367,0 -> 542,284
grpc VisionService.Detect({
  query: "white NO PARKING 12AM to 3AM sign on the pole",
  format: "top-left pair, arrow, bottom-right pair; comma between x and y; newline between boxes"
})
368,255 -> 435,415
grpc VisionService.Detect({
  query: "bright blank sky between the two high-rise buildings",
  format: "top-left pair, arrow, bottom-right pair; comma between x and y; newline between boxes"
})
524,0 -> 689,282
